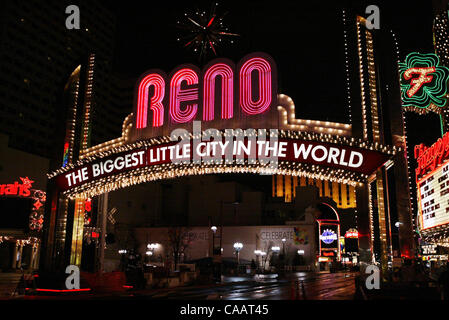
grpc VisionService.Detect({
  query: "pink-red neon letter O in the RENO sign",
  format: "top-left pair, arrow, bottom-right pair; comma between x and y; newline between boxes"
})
240,58 -> 272,115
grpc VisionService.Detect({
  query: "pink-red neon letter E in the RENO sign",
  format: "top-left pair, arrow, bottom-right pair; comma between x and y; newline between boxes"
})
169,68 -> 199,123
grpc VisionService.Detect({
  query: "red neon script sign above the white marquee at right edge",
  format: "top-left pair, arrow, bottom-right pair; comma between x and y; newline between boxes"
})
415,132 -> 449,180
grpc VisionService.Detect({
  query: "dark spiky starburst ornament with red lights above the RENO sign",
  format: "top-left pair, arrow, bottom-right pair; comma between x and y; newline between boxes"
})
177,3 -> 240,61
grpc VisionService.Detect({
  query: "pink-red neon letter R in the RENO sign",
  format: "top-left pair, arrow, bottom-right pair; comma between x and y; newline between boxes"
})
137,73 -> 165,129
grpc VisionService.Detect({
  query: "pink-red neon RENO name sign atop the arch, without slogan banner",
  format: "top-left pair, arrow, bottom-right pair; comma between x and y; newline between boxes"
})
134,53 -> 278,139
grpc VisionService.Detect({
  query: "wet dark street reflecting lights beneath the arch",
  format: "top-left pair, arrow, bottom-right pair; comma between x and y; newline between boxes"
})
16,272 -> 357,300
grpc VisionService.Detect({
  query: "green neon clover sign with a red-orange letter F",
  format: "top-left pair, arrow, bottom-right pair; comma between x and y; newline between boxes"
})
399,52 -> 449,113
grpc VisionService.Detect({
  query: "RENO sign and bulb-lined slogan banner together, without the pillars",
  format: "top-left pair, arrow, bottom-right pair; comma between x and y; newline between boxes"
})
48,53 -> 396,198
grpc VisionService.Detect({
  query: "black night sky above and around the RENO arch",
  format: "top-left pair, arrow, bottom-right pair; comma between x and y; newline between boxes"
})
106,0 -> 435,139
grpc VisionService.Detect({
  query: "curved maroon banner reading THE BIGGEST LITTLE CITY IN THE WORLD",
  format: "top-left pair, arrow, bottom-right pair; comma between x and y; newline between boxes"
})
51,137 -> 389,195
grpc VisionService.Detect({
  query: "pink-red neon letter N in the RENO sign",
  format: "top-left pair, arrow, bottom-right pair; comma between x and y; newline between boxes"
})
203,63 -> 234,121
